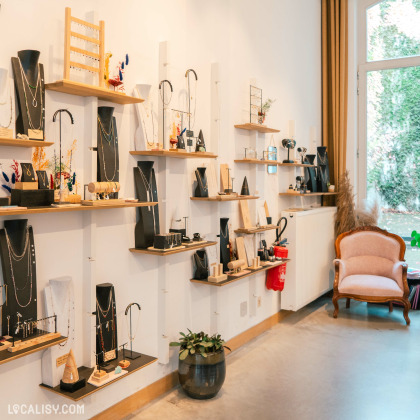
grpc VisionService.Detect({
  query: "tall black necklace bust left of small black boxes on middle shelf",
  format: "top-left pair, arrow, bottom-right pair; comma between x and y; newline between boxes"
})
134,161 -> 160,248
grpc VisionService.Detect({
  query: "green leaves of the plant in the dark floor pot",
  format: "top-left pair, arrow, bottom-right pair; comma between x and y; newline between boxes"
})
169,330 -> 231,360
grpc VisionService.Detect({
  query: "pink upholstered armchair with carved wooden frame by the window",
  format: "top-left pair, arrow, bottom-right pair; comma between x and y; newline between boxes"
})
332,226 -> 410,325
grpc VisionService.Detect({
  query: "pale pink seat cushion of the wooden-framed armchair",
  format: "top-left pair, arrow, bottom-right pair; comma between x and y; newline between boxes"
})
338,274 -> 403,297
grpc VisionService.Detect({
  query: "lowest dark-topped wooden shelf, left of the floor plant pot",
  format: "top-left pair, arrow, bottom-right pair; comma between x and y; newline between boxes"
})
39,350 -> 157,401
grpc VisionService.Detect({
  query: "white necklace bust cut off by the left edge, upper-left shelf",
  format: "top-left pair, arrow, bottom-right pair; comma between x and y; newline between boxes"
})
0,69 -> 16,139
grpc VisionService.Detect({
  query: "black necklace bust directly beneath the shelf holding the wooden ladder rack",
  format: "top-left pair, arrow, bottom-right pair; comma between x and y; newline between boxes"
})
97,106 -> 120,199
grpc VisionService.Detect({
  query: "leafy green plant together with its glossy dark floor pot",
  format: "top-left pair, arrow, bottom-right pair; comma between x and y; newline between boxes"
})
169,330 -> 230,400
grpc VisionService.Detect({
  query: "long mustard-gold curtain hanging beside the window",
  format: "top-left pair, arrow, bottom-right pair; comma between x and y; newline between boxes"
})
322,0 -> 348,188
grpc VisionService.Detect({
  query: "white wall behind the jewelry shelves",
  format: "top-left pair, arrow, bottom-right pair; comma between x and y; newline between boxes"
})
0,0 -> 321,418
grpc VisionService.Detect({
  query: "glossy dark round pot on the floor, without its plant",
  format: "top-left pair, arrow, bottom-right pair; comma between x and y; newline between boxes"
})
178,350 -> 226,400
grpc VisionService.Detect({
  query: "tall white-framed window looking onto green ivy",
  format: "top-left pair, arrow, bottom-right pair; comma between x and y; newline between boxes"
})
359,0 -> 420,269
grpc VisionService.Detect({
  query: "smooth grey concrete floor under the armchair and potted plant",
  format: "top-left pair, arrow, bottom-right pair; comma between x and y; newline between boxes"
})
130,298 -> 420,420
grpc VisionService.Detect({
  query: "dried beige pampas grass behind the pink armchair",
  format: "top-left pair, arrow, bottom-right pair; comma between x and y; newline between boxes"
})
334,171 -> 380,237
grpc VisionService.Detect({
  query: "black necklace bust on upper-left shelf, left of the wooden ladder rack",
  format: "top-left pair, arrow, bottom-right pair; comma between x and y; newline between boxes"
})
12,50 -> 45,141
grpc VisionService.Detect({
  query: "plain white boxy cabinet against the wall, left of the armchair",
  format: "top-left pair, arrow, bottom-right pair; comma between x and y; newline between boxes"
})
281,207 -> 337,311
